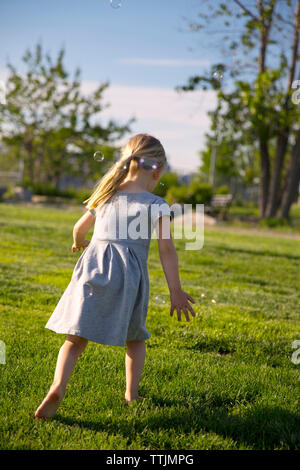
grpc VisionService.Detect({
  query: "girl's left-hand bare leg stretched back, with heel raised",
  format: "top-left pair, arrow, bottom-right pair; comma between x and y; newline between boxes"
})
35,335 -> 88,418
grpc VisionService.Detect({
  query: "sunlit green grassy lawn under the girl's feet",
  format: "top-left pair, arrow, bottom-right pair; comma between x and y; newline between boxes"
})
0,204 -> 300,450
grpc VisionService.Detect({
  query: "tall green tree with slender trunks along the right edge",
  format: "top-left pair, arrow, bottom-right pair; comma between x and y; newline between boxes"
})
178,0 -> 300,218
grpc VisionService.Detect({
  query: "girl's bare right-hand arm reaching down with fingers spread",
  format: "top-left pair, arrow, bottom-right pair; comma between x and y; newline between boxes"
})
157,215 -> 196,321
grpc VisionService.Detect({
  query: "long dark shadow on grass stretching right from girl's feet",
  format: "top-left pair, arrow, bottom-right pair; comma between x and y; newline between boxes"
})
54,398 -> 300,450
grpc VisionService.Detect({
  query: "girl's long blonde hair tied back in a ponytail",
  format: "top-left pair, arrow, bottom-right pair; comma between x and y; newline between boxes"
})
83,134 -> 167,209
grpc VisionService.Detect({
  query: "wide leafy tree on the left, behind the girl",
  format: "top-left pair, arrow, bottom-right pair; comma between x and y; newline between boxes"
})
0,44 -> 133,187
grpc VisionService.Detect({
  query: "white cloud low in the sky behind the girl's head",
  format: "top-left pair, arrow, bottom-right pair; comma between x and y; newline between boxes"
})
83,82 -> 217,173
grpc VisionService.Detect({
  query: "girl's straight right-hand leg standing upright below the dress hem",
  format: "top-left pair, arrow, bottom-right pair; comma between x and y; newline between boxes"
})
125,340 -> 146,403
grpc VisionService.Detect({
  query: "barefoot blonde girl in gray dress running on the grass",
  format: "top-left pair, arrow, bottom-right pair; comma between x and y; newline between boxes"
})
35,134 -> 195,419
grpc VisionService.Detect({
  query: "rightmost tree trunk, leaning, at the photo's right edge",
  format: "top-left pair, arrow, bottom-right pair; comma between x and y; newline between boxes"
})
280,131 -> 300,219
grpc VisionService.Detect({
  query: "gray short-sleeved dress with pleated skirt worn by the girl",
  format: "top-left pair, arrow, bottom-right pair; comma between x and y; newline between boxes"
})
46,191 -> 171,346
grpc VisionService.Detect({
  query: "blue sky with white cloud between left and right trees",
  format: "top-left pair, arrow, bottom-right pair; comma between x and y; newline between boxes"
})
0,0 -> 223,172
